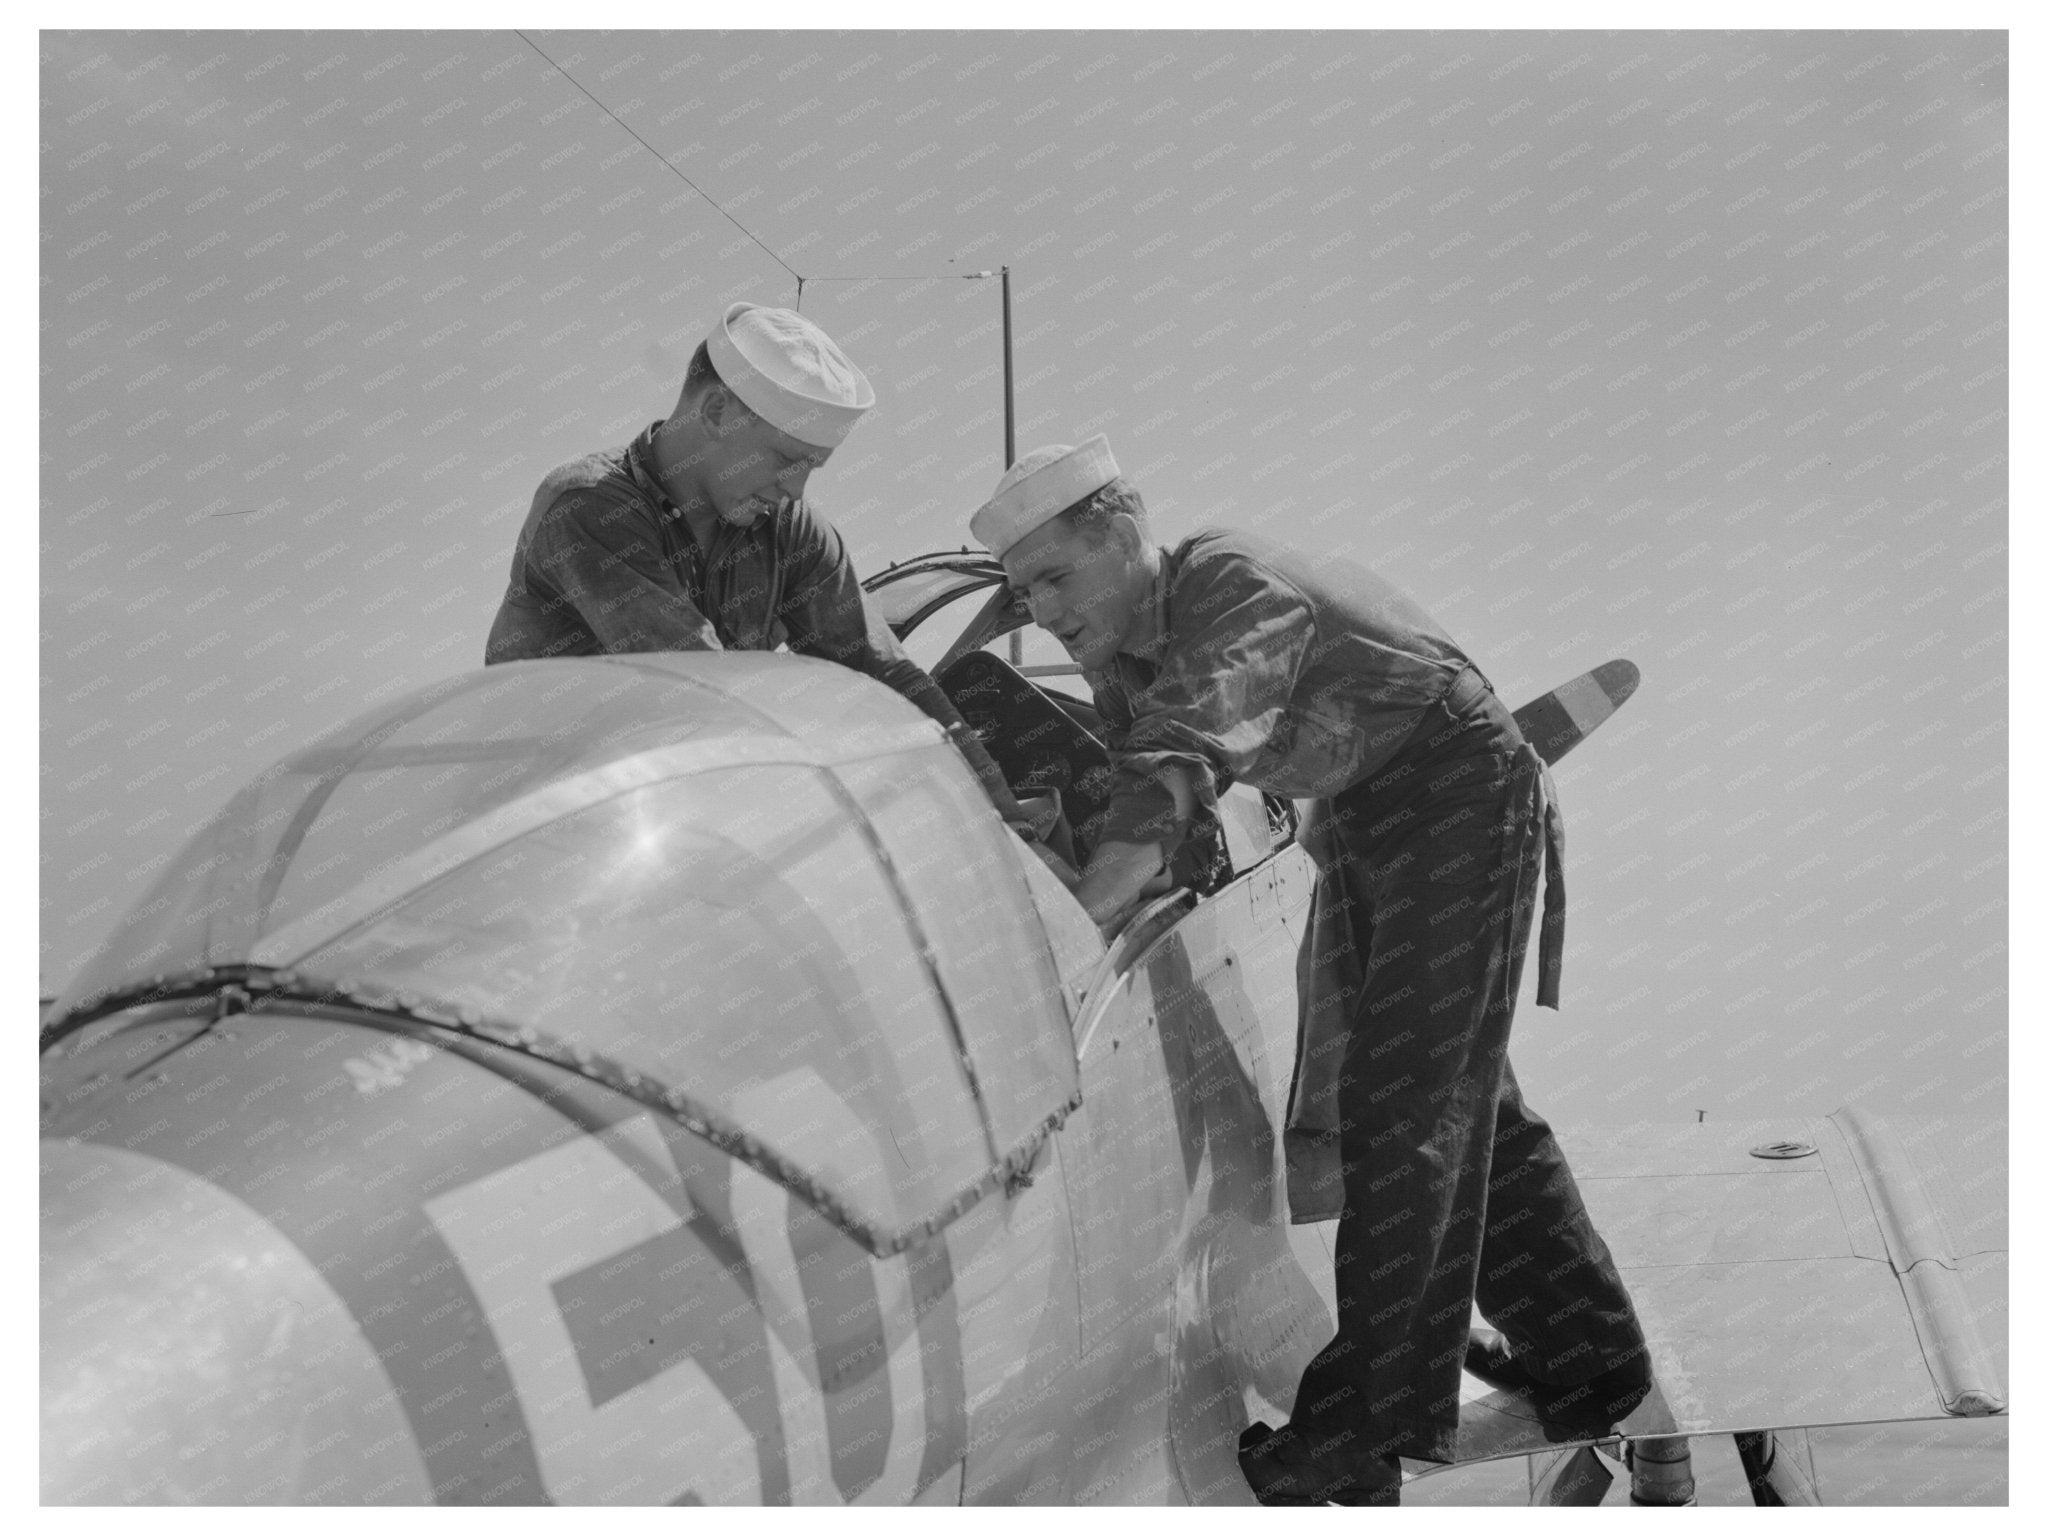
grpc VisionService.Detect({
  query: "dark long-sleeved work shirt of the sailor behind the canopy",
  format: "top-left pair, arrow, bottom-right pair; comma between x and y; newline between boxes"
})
483,422 -> 1022,825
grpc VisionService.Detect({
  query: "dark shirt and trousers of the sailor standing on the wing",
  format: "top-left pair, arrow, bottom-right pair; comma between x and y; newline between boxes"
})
1090,530 -> 1642,1460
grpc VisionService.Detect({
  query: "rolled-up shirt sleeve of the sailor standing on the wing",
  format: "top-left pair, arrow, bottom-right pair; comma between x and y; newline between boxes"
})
1096,555 -> 1315,854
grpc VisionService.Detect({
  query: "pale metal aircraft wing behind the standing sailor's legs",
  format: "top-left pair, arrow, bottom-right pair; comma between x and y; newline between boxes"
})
1540,1108 -> 2007,1434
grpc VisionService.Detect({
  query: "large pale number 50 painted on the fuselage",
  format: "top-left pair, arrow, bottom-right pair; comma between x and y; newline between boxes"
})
426,1114 -> 965,1503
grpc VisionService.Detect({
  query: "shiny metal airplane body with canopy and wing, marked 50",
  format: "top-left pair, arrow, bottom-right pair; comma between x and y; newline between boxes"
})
41,643 -> 2005,1503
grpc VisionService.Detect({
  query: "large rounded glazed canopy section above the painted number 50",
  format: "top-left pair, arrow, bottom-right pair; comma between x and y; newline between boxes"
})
51,653 -> 1077,1253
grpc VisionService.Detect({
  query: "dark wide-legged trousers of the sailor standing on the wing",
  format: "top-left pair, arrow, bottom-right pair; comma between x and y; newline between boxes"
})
1292,670 -> 1642,1460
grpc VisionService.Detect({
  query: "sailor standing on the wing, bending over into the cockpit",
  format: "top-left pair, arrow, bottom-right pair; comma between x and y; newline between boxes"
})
971,436 -> 1651,1503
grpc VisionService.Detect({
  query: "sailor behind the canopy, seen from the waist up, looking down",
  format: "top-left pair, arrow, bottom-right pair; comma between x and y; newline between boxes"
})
483,303 -> 1026,831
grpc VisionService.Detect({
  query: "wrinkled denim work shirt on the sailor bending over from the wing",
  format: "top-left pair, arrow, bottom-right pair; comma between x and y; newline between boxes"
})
1085,528 -> 1470,854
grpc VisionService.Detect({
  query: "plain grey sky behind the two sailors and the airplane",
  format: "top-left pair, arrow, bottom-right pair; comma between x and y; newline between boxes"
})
39,31 -> 2007,1122
